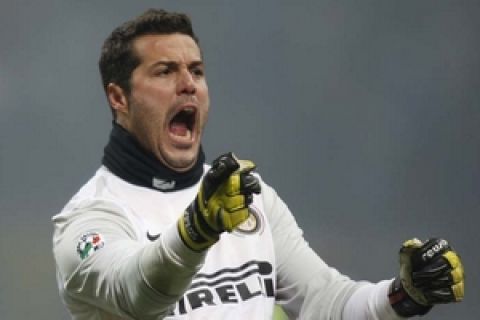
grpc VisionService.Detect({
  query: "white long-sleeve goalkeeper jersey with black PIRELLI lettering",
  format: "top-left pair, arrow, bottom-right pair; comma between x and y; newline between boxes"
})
53,167 -> 400,320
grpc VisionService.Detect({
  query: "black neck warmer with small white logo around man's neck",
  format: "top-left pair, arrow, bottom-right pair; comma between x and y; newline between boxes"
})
102,123 -> 205,192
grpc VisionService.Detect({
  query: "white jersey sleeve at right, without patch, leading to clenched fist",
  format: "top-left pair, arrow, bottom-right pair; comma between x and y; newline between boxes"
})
262,184 -> 398,320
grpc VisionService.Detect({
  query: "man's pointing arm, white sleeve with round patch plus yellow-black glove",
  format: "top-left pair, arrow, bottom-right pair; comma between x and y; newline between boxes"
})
54,154 -> 259,319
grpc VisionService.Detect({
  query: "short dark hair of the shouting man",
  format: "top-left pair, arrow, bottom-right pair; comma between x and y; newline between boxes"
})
98,9 -> 198,117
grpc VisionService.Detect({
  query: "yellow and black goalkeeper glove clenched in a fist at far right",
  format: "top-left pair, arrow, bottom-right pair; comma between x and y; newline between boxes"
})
388,239 -> 465,317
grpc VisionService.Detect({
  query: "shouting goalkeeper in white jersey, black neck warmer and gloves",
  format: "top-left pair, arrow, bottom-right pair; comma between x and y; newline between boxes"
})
53,10 -> 464,320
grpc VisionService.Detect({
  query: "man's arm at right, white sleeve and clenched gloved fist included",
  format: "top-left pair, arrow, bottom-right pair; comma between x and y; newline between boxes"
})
262,181 -> 464,320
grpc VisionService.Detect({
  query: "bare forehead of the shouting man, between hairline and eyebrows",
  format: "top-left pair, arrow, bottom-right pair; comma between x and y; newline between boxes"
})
133,33 -> 201,63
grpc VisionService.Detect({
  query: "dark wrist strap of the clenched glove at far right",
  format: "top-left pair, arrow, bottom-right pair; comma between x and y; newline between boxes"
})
388,278 -> 432,318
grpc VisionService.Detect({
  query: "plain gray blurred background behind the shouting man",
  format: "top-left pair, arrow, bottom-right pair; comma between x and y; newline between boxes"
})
0,0 -> 480,320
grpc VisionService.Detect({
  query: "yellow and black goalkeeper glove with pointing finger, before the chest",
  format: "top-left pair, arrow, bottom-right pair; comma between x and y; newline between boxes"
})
178,153 -> 260,251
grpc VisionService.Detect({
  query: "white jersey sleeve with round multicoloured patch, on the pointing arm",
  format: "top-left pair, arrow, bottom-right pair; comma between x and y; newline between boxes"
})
53,201 -> 204,320
